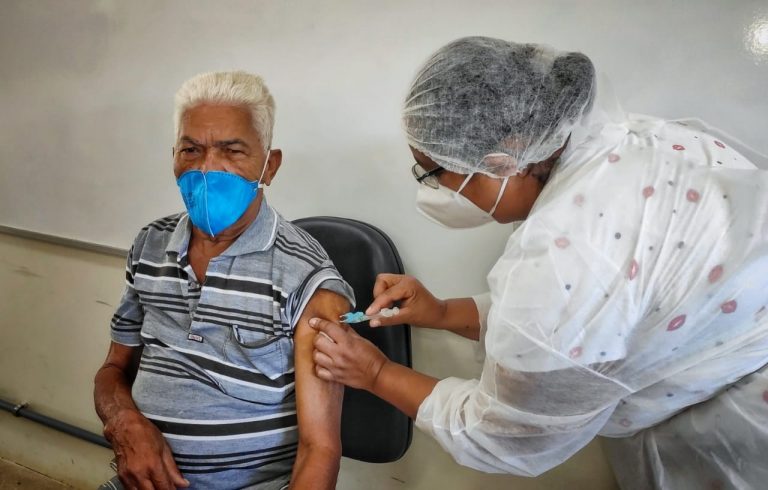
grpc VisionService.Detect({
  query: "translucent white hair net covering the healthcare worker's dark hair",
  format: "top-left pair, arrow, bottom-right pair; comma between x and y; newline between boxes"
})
403,37 -> 595,176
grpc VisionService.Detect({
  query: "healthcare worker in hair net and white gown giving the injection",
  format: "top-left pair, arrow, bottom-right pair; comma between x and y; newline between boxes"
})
311,37 -> 768,489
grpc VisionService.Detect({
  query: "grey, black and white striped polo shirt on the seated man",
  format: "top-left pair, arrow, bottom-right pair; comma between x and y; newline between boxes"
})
111,200 -> 354,489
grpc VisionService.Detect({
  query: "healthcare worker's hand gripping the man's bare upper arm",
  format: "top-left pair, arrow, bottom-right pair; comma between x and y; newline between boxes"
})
309,318 -> 389,391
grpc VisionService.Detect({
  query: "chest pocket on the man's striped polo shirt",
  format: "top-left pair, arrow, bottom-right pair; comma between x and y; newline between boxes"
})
223,325 -> 295,404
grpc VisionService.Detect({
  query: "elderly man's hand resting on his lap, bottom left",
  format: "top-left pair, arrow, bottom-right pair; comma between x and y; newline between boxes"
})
104,410 -> 189,490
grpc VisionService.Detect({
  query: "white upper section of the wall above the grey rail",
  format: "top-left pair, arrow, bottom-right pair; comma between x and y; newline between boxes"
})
0,0 -> 768,253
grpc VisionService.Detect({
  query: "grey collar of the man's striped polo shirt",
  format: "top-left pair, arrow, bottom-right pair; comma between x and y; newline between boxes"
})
165,199 -> 278,257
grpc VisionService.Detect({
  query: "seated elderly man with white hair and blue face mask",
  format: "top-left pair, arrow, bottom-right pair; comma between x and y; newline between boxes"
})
94,72 -> 354,489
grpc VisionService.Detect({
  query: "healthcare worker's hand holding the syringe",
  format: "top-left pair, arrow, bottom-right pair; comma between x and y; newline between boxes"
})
365,274 -> 446,328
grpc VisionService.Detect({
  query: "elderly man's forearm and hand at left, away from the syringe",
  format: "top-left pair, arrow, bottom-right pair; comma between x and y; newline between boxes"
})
93,342 -> 189,490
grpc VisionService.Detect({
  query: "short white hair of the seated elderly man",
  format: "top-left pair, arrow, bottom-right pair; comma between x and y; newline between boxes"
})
173,71 -> 275,150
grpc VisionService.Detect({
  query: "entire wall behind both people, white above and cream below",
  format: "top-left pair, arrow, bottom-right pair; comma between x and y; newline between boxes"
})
0,0 -> 768,489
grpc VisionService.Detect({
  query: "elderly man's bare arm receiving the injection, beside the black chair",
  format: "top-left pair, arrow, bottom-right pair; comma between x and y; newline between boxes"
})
291,289 -> 349,490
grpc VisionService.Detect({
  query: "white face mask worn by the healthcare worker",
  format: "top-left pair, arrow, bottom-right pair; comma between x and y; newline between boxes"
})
416,174 -> 509,228
